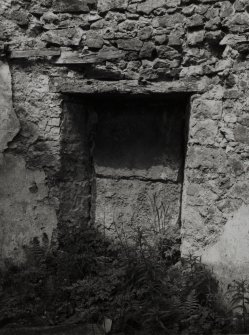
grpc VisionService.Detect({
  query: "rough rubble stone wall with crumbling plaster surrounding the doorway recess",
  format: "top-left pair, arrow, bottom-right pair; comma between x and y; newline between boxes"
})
0,0 -> 249,288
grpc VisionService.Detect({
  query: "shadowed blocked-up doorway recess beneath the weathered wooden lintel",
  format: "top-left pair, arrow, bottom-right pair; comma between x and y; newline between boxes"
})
60,94 -> 189,256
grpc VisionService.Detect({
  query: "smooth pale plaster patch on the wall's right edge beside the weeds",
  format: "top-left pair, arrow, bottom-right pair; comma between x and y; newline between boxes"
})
202,205 -> 249,283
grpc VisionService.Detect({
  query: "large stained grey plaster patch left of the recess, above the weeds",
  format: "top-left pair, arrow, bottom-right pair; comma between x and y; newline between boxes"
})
0,154 -> 57,261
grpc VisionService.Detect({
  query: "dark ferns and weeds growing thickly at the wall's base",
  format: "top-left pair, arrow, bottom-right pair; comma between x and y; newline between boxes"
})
0,225 -> 239,335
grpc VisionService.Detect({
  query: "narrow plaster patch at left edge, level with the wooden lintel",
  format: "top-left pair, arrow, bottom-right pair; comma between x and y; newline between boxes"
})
0,61 -> 20,153
